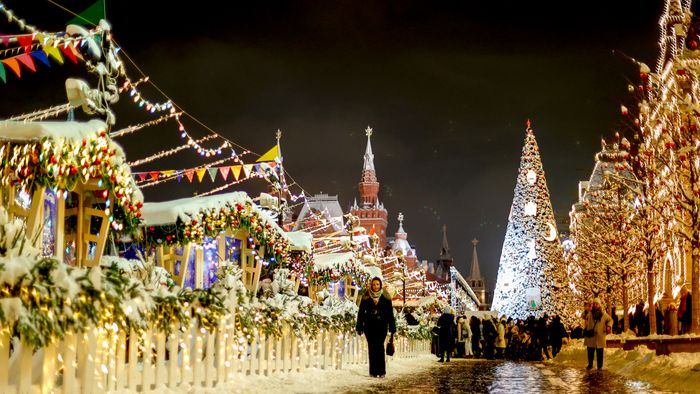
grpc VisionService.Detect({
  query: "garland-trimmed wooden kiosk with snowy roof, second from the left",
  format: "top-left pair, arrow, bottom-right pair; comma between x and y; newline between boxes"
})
142,192 -> 308,293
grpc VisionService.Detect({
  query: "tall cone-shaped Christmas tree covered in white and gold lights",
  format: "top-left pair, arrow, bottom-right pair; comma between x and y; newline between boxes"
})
492,121 -> 568,319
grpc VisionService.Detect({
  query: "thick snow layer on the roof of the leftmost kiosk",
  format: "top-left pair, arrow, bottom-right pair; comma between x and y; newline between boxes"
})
0,119 -> 107,141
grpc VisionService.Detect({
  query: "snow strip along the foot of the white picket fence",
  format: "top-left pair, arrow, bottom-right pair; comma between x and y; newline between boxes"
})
114,354 -> 435,394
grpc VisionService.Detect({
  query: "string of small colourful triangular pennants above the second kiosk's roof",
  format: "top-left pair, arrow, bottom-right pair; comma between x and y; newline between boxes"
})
132,161 -> 277,183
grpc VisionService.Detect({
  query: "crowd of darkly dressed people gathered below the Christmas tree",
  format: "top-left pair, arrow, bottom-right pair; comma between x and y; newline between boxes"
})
432,307 -> 569,362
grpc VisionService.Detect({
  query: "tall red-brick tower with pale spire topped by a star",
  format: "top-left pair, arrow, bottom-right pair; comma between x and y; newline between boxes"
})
350,126 -> 388,249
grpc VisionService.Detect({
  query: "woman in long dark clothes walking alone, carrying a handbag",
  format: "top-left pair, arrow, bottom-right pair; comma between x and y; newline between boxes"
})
355,277 -> 396,377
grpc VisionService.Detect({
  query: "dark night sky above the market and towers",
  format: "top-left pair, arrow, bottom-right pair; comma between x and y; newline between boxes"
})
0,0 -> 680,296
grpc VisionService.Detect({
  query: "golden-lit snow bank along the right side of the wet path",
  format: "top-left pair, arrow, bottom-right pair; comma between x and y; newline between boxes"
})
554,340 -> 700,393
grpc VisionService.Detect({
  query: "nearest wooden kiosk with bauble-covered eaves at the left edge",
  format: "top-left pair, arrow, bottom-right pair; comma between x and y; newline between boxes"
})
0,120 -> 143,267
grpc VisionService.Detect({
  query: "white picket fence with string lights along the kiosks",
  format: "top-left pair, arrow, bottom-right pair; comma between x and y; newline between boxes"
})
0,320 -> 430,394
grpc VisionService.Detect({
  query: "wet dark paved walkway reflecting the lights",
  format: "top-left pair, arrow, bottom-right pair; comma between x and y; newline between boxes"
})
347,359 -> 680,394
